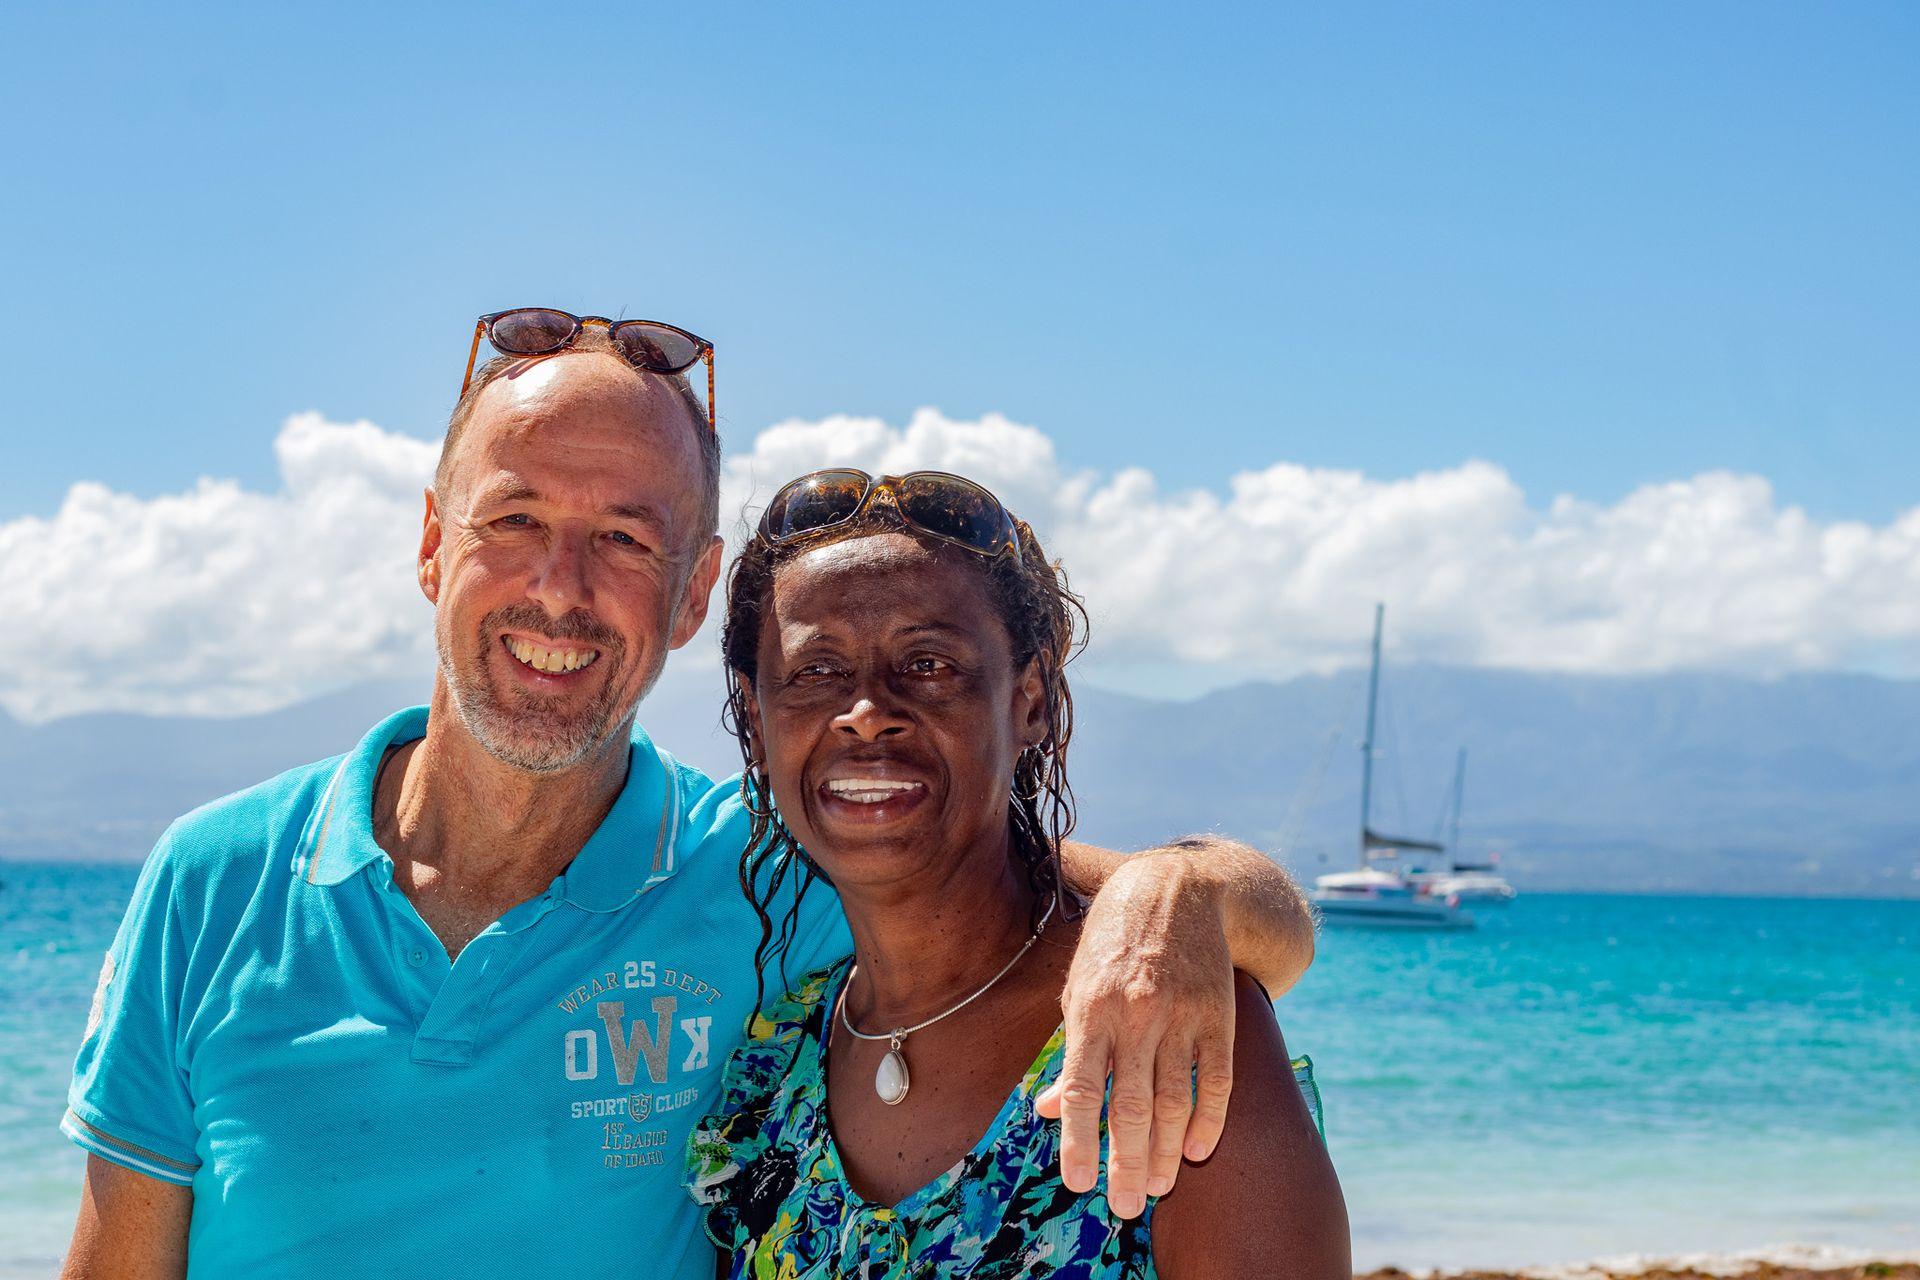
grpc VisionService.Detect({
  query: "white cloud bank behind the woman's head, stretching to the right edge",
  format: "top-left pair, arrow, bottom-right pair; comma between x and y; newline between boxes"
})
728,409 -> 1920,679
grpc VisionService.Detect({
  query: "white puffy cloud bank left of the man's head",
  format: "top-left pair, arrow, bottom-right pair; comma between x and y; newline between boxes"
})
0,415 -> 438,720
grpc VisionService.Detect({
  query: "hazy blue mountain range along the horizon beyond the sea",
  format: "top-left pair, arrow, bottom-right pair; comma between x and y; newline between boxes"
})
0,664 -> 1920,898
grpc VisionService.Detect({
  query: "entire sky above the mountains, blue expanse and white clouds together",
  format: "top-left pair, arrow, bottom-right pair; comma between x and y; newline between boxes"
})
0,2 -> 1920,720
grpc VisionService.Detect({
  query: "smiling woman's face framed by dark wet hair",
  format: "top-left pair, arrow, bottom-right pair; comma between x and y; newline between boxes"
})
747,533 -> 1044,889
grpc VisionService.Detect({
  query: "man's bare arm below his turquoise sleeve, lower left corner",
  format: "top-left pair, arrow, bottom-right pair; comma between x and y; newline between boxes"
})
60,1155 -> 194,1280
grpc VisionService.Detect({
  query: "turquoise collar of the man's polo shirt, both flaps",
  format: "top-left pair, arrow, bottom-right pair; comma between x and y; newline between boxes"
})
292,706 -> 684,912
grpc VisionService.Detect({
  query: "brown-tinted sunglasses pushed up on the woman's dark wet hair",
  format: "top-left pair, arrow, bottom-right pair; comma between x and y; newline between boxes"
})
760,468 -> 1020,560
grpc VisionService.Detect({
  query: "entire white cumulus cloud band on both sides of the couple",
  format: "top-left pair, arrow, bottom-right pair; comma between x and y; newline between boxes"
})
0,409 -> 1920,720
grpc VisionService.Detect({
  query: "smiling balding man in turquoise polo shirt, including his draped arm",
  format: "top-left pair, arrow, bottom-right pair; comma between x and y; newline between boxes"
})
63,318 -> 1311,1278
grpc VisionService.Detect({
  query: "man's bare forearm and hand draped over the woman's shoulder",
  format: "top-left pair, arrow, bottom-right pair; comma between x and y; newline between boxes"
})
1039,835 -> 1313,1217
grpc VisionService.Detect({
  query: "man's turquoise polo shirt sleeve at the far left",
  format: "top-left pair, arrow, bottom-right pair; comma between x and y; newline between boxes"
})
60,829 -> 200,1186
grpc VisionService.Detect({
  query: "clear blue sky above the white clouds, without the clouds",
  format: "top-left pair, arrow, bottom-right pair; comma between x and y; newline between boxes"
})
0,4 -> 1920,522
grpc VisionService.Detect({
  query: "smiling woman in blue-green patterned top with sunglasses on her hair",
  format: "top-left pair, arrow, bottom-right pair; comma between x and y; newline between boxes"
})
689,470 -> 1350,1280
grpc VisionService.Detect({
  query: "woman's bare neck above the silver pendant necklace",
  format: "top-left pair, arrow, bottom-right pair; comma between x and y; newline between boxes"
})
841,850 -> 1044,1032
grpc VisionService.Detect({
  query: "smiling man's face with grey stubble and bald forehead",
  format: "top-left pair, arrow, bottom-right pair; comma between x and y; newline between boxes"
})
420,353 -> 720,773
